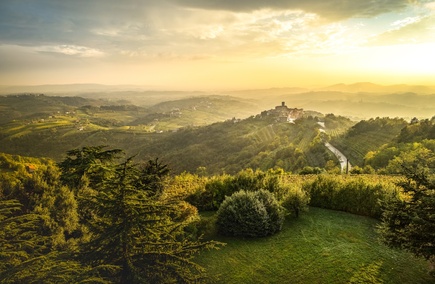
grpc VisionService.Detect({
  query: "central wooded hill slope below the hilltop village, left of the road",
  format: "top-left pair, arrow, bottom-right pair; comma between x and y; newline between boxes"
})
133,113 -> 348,173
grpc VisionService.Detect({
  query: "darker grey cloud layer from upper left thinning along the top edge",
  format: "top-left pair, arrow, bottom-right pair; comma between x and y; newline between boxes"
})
0,0 -> 418,53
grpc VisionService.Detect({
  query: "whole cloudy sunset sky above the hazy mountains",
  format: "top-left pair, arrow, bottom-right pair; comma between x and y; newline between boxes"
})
0,0 -> 435,90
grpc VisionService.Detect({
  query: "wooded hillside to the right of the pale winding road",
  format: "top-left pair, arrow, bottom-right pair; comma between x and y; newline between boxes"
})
331,118 -> 435,174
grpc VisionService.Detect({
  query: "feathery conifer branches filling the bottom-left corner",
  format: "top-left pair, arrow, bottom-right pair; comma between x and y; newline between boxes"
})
0,200 -> 116,283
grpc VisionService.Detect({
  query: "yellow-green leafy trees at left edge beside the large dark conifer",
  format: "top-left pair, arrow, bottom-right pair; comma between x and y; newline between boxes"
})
0,154 -> 79,246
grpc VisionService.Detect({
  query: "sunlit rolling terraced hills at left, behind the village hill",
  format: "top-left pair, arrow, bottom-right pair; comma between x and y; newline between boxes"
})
0,94 -> 262,160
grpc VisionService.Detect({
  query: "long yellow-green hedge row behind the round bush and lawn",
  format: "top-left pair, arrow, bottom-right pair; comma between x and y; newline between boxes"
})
170,169 -> 403,219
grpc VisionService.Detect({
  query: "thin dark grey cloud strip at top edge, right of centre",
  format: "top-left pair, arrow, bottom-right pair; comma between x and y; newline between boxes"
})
172,0 -> 409,20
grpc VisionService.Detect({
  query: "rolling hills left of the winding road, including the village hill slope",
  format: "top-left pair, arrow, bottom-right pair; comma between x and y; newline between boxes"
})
0,95 -> 354,174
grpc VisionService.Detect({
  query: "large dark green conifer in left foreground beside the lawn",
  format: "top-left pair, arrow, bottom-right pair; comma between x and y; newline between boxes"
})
63,149 -> 223,283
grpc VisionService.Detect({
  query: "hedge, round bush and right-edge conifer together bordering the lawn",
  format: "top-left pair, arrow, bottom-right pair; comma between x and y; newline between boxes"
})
172,162 -> 435,270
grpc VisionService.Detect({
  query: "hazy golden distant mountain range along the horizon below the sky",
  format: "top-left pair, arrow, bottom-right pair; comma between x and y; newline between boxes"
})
0,82 -> 435,120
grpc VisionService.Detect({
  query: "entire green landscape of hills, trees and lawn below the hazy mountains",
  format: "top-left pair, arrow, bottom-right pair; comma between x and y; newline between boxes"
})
0,88 -> 435,283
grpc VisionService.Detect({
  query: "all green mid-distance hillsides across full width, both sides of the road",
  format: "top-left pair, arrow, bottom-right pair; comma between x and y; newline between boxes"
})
0,95 -> 435,174
